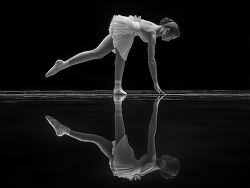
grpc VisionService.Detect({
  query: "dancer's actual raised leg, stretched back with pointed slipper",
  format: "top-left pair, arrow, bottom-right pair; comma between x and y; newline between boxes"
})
45,34 -> 114,77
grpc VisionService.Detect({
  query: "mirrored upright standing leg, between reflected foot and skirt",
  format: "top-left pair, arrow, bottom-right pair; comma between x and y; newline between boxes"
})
115,100 -> 125,143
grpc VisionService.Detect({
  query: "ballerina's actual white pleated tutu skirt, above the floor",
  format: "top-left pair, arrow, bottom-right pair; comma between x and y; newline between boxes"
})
109,15 -> 141,61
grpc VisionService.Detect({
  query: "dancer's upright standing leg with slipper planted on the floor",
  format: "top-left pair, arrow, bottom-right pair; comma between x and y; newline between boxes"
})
113,49 -> 127,95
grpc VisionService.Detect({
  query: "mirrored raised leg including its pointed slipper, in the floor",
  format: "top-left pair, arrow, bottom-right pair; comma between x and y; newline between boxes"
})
45,116 -> 113,159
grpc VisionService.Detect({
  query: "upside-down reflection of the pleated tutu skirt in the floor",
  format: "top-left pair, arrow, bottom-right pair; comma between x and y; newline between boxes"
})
110,135 -> 139,179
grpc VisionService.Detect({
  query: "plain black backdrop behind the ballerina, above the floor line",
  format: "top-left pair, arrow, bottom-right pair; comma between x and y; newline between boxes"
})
0,0 -> 250,90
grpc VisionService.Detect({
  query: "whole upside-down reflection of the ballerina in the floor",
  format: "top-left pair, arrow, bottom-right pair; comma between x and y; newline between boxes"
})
46,96 -> 180,180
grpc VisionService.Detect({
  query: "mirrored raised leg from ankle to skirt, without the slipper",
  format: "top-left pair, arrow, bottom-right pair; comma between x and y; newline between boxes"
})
68,130 -> 113,159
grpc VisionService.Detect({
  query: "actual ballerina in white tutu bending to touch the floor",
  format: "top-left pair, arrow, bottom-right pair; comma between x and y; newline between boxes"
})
45,14 -> 180,94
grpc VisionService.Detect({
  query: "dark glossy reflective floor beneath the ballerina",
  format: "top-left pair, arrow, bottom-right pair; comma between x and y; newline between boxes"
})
0,90 -> 250,187
